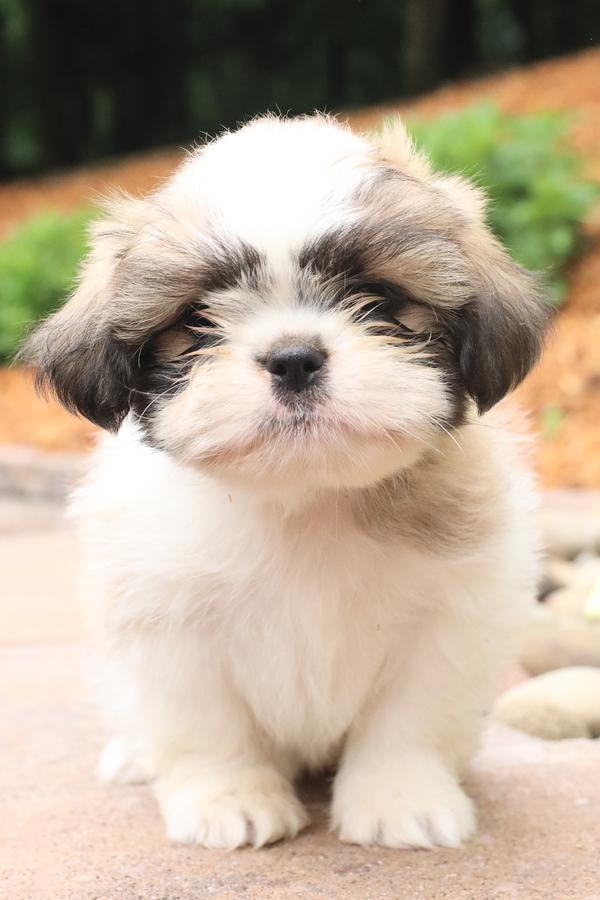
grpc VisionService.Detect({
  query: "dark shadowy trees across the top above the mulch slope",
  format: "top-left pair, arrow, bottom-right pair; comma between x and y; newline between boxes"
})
0,0 -> 600,180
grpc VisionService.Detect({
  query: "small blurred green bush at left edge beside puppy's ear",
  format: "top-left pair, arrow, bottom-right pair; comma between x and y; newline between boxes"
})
0,209 -> 92,360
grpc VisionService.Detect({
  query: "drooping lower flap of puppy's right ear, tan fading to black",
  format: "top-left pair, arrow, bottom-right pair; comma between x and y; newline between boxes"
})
451,234 -> 550,413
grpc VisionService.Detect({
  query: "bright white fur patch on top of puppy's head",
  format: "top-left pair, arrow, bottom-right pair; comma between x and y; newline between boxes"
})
169,117 -> 374,258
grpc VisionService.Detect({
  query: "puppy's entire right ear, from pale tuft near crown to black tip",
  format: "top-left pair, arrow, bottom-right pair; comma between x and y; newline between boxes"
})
374,119 -> 549,412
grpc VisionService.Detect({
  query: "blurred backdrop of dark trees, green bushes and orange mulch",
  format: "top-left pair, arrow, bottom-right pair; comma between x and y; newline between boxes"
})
0,0 -> 600,487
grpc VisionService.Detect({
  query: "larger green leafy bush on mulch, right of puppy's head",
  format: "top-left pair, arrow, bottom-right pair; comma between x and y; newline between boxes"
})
409,104 -> 598,302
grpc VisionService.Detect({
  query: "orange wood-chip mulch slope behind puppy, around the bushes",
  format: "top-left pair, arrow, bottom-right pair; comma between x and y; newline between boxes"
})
0,50 -> 600,488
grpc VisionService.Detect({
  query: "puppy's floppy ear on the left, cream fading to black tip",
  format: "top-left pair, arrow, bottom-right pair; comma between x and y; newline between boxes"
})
18,197 -> 142,430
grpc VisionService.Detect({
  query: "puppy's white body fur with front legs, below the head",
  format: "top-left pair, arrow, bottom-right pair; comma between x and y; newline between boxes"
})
76,412 -> 534,847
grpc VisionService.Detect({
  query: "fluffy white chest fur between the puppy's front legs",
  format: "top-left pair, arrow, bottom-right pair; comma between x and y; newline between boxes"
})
218,528 -> 420,764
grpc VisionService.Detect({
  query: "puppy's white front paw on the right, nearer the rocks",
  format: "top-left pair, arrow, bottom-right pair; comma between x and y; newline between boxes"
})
332,758 -> 475,848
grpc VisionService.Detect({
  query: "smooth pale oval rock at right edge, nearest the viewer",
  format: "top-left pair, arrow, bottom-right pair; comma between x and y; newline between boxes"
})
492,666 -> 600,740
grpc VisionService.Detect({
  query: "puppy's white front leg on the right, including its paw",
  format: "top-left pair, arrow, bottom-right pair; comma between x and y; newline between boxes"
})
332,600 -> 508,847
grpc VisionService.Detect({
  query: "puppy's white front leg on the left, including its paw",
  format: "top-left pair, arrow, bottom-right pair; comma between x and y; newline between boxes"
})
103,633 -> 308,848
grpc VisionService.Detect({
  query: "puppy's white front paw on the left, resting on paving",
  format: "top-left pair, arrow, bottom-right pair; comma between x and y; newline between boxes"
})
157,768 -> 308,850
